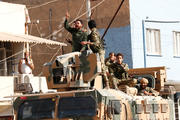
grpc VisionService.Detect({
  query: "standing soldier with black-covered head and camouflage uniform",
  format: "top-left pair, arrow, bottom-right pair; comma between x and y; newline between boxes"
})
81,20 -> 109,88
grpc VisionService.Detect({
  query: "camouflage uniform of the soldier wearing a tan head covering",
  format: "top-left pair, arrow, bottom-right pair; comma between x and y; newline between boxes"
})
138,87 -> 159,96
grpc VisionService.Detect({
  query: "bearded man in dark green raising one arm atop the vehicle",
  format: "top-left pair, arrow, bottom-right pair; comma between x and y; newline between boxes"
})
64,12 -> 87,52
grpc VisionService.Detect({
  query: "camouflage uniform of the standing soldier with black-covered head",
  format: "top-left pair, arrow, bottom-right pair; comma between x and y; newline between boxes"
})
88,28 -> 109,88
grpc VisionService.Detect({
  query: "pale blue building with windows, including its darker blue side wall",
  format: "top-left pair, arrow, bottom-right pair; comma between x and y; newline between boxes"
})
98,0 -> 180,81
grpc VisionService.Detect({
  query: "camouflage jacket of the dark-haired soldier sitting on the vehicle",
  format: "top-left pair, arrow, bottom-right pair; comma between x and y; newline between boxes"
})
109,63 -> 129,79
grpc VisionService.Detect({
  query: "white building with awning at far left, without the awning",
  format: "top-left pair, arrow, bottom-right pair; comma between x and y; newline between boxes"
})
0,2 -> 28,76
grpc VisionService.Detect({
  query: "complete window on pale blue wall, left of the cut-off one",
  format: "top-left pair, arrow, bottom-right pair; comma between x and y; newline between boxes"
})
146,29 -> 161,55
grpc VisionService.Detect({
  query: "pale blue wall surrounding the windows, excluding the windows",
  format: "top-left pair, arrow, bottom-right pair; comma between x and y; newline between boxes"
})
129,0 -> 180,81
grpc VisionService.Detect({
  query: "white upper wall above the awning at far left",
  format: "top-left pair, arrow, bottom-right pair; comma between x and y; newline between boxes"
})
0,2 -> 26,34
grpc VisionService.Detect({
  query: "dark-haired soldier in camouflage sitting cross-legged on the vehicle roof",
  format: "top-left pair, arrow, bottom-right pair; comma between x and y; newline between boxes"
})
109,53 -> 137,89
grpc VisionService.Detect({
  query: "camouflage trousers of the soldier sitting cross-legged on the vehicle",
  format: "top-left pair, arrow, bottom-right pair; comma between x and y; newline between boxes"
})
109,76 -> 137,89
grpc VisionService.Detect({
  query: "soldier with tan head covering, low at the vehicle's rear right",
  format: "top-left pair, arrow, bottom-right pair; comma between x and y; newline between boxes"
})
138,78 -> 159,96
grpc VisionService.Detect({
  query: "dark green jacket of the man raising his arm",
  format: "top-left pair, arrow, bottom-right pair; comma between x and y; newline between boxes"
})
64,19 -> 88,52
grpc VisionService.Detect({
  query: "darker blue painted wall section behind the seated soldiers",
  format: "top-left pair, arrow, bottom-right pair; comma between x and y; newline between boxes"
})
100,26 -> 133,68
